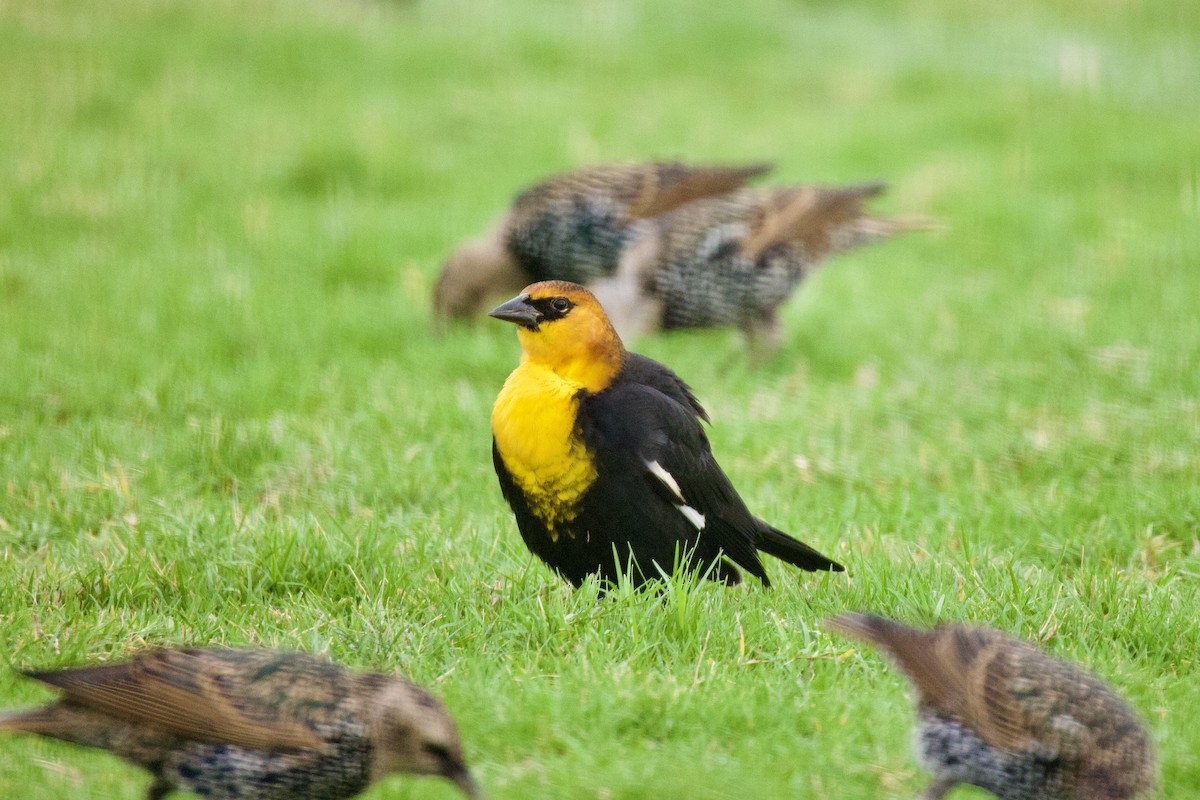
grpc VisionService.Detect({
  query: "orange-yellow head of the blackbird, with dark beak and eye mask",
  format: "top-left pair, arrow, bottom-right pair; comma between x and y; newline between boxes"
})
488,281 -> 625,392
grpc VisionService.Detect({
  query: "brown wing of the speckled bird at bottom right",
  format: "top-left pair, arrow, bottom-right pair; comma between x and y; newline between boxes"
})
826,614 -> 1034,750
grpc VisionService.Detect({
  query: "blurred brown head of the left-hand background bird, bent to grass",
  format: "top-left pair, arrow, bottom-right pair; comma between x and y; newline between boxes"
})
433,234 -> 528,319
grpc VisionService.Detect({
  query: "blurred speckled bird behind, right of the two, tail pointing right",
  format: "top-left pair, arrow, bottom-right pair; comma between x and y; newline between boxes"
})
604,182 -> 931,354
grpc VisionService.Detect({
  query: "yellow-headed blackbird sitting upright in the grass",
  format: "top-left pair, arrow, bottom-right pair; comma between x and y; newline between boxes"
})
491,281 -> 842,585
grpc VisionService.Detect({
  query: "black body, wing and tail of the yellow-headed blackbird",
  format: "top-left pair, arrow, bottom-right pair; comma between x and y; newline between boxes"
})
493,354 -> 840,585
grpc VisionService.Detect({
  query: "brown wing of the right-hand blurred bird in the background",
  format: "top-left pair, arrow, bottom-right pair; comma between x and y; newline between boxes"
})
742,182 -> 887,260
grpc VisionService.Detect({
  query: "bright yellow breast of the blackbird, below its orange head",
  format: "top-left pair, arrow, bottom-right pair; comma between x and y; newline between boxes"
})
492,361 -> 596,541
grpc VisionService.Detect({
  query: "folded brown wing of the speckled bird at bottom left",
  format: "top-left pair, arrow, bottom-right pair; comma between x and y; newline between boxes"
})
26,649 -> 323,750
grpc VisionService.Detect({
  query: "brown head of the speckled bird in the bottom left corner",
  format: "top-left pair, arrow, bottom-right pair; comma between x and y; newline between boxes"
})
370,679 -> 484,800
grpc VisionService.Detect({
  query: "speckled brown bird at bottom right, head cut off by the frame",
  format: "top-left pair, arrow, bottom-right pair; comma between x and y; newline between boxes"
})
826,614 -> 1156,800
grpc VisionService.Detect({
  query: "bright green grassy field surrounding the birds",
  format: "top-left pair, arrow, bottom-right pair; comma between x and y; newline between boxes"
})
0,0 -> 1200,800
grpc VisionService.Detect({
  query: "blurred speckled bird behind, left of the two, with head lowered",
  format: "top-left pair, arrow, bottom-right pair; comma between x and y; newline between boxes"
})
433,162 -> 770,318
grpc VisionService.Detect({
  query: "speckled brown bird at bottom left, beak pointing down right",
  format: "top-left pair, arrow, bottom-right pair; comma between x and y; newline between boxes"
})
0,648 -> 480,800
